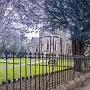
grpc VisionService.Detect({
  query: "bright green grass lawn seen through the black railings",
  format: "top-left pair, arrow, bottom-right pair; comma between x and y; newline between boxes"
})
0,59 -> 74,83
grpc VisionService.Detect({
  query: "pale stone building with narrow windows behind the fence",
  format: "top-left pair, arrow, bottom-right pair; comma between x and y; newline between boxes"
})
31,31 -> 72,55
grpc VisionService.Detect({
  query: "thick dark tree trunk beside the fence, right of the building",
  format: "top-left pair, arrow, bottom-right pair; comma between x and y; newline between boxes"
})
72,40 -> 84,71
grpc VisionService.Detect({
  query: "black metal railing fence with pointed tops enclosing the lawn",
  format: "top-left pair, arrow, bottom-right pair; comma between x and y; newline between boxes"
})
0,52 -> 90,90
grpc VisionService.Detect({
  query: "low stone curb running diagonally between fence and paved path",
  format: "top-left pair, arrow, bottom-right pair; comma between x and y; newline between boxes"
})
51,73 -> 90,90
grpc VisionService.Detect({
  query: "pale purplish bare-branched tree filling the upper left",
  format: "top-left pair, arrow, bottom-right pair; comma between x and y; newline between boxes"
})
0,0 -> 43,51
